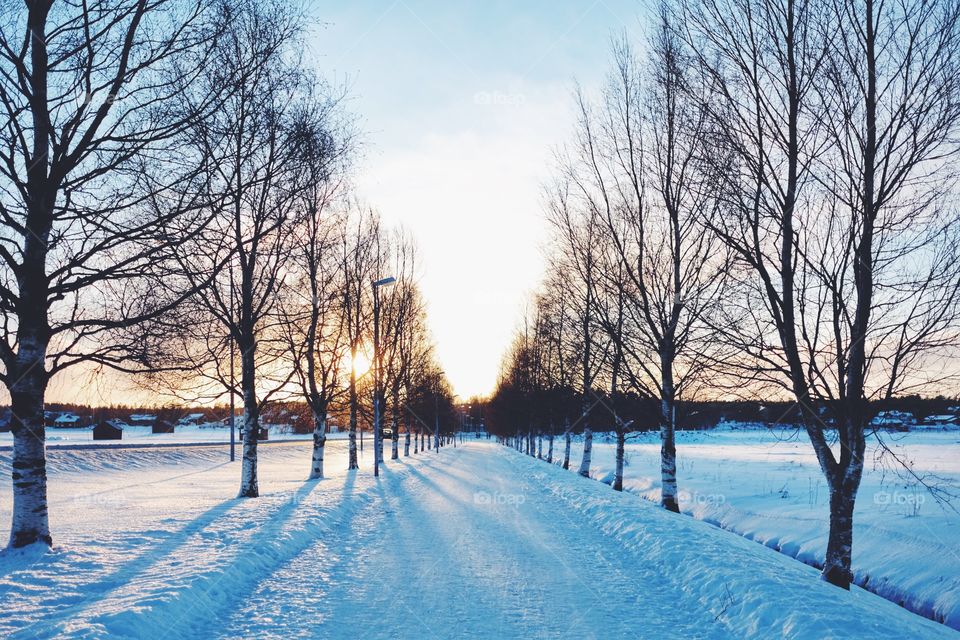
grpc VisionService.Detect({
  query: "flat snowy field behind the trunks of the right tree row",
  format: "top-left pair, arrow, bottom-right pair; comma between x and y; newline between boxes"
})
555,428 -> 960,629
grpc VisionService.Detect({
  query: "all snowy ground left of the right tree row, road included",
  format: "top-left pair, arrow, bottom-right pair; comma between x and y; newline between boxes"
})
0,442 -> 956,640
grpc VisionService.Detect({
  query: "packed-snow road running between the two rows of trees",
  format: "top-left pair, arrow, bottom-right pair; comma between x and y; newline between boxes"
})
225,446 -> 727,638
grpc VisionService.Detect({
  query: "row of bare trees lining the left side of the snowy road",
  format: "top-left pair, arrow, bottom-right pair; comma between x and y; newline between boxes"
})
0,0 -> 452,547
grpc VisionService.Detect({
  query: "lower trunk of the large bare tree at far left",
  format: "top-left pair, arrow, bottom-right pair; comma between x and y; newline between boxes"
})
10,356 -> 53,547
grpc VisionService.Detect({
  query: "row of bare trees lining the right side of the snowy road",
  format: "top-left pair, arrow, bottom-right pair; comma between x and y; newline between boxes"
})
491,0 -> 960,588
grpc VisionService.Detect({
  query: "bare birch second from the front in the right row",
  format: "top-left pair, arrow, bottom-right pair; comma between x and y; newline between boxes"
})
568,27 -> 727,511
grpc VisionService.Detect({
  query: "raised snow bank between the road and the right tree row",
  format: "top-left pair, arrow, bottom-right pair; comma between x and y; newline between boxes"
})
504,449 -> 956,639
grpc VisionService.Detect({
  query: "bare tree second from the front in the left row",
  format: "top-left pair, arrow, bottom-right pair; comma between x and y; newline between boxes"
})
153,2 -> 310,497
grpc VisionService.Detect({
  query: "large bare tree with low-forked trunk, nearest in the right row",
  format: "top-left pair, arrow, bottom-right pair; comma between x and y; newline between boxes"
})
685,0 -> 960,588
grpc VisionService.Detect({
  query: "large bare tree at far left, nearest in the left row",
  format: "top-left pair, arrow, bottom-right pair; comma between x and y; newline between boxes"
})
0,0 -> 222,547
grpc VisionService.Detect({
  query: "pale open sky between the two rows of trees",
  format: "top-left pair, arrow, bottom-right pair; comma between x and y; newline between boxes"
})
308,0 -> 643,399
